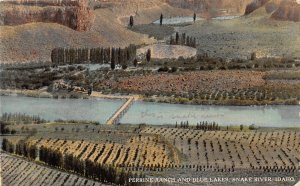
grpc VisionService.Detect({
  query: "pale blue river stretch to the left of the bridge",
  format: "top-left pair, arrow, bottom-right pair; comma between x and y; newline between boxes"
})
0,96 -> 124,123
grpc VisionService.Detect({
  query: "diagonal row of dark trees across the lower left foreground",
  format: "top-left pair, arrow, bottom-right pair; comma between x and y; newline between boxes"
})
2,138 -> 143,185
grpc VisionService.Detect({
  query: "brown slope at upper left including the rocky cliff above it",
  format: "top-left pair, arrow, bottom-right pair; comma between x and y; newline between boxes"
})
0,1 -> 162,63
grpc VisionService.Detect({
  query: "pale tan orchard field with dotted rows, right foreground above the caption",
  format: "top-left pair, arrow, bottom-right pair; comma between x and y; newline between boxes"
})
142,127 -> 300,171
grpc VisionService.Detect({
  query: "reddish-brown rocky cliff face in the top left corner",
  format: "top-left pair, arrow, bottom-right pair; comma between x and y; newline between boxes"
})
0,0 -> 94,31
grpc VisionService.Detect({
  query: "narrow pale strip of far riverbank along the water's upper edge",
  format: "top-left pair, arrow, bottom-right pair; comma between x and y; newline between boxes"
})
0,89 -> 300,106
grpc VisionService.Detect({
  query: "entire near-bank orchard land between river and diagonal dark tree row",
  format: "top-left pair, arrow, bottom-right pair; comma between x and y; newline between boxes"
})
2,124 -> 300,172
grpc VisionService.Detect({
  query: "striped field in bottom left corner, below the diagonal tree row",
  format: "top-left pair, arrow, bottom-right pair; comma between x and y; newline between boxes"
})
0,154 -> 102,186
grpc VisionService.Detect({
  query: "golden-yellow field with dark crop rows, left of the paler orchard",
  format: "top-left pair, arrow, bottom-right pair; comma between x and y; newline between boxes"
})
30,136 -> 178,167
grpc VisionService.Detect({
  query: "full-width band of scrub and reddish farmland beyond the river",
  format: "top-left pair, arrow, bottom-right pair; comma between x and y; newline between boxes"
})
0,61 -> 300,105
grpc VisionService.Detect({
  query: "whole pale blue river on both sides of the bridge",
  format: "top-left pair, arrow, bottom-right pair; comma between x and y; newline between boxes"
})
0,96 -> 300,127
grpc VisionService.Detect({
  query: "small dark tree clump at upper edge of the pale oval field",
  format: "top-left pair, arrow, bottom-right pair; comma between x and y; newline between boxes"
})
170,32 -> 197,48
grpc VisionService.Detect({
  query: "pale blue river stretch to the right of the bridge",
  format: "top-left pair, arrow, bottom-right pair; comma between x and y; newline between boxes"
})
121,102 -> 300,127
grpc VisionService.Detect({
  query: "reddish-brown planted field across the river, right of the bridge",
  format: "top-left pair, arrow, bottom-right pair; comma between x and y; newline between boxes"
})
96,70 -> 300,105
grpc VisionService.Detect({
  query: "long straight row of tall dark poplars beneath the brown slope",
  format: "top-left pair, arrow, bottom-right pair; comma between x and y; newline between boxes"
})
51,45 -> 137,66
